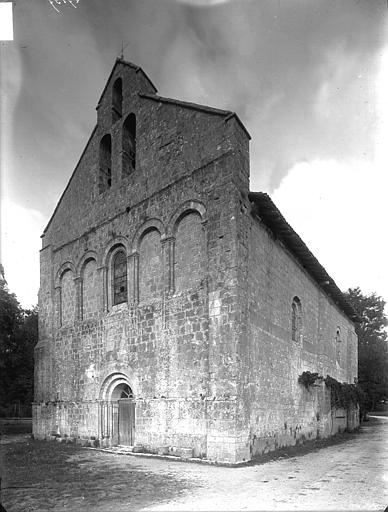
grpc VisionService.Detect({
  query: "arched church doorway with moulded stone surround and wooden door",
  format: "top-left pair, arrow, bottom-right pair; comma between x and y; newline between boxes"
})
101,373 -> 135,446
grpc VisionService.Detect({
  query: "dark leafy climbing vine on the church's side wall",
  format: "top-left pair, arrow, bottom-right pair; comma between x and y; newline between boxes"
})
298,372 -> 365,409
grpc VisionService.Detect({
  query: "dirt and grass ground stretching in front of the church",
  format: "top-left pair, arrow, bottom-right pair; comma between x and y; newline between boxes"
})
0,417 -> 388,512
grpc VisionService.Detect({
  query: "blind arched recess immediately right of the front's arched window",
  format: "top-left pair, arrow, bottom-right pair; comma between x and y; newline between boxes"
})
138,227 -> 164,301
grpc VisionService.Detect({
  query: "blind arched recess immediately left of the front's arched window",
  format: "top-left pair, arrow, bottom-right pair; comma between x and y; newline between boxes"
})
80,256 -> 98,320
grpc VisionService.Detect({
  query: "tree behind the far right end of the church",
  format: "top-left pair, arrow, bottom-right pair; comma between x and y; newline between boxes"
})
345,287 -> 388,410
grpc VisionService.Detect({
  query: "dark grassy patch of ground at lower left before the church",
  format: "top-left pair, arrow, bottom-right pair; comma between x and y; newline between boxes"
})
0,439 -> 194,512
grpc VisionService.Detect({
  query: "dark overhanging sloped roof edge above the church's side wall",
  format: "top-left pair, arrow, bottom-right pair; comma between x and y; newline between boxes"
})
248,192 -> 361,322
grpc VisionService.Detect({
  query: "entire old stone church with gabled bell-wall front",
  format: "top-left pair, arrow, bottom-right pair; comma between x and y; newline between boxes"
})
33,59 -> 357,463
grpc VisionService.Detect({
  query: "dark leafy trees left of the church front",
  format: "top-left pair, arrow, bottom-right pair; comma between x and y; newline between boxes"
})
0,272 -> 38,414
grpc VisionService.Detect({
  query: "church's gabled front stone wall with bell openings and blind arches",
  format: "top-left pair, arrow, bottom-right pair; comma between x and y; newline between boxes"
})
34,58 -> 249,461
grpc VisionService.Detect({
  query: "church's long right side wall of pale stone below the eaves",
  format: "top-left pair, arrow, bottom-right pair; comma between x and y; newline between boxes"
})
241,214 -> 358,456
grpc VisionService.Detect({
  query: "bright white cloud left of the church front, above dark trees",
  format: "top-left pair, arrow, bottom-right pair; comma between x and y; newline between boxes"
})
1,198 -> 46,308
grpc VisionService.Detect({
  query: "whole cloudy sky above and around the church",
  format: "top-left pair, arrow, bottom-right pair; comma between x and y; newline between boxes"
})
0,0 -> 388,307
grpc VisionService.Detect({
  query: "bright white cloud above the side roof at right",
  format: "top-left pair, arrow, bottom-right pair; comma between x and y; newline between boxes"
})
273,47 -> 388,306
